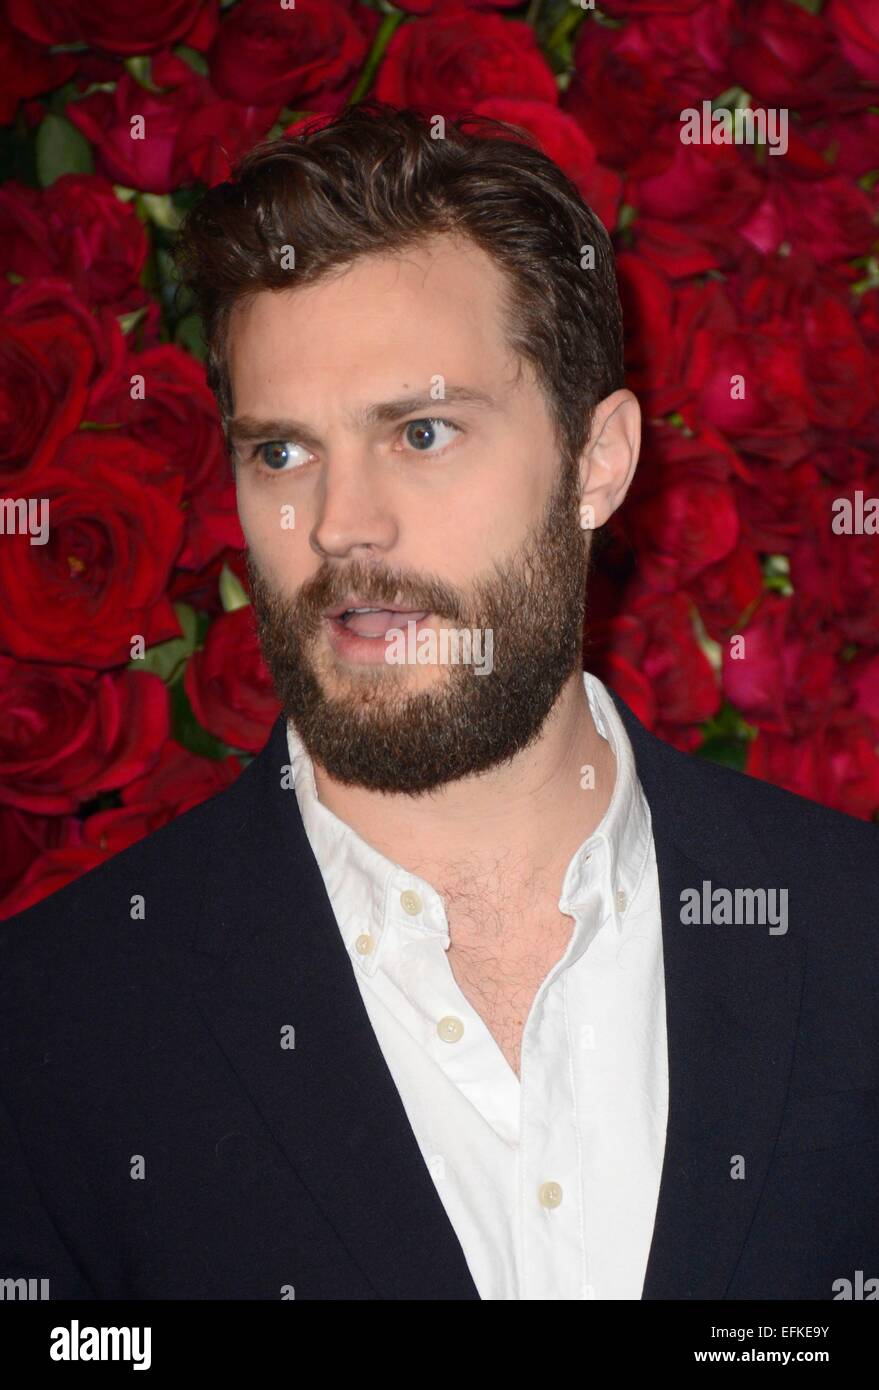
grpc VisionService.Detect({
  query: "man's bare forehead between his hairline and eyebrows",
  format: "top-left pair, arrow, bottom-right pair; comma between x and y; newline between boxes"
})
228,236 -> 515,413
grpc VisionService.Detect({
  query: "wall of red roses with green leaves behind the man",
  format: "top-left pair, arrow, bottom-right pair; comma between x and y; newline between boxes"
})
0,0 -> 879,916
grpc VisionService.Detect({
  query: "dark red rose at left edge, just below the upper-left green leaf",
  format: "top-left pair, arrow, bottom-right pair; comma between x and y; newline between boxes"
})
0,174 -> 147,313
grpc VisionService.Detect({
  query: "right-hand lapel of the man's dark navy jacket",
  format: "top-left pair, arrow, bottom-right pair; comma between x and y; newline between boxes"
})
611,692 -> 808,1298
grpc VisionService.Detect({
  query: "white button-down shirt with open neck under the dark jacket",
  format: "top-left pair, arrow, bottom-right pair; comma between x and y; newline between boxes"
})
288,671 -> 668,1300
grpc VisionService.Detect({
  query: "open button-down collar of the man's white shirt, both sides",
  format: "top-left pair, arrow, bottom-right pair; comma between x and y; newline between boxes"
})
287,671 -> 651,974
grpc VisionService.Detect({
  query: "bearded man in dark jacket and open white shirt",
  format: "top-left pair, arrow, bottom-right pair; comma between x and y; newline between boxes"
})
0,106 -> 879,1300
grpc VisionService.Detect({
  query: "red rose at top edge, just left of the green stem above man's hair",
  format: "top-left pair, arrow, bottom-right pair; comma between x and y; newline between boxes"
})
210,0 -> 367,106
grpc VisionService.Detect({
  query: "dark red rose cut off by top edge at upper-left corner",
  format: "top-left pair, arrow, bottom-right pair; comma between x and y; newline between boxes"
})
7,0 -> 217,53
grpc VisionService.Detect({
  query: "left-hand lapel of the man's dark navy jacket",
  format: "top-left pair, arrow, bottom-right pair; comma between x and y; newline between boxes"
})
179,717 -> 478,1300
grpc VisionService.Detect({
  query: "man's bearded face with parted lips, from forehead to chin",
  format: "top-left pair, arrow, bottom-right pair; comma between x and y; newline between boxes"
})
229,238 -> 588,794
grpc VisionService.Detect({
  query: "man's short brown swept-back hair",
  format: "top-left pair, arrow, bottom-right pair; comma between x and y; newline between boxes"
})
175,99 -> 623,459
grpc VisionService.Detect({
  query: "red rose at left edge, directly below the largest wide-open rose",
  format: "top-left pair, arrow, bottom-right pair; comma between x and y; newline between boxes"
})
0,656 -> 168,815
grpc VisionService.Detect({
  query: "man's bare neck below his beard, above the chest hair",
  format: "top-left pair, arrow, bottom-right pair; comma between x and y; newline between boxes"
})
314,671 -> 615,888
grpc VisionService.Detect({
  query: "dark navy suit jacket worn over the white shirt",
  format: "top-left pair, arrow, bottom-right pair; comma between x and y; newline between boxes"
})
0,695 -> 879,1300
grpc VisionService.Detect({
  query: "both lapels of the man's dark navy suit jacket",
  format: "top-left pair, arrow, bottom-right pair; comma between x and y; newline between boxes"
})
176,692 -> 805,1300
